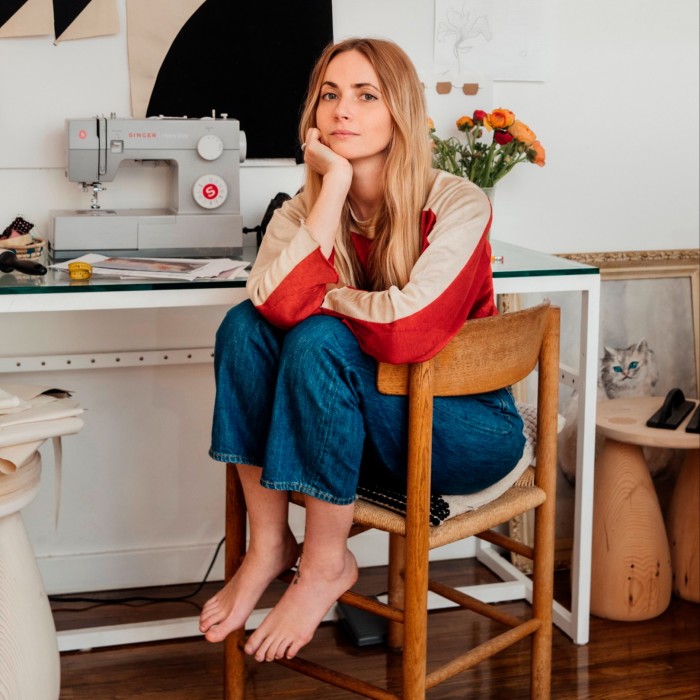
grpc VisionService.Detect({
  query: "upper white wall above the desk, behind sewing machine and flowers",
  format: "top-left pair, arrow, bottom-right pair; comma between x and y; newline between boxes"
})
0,0 -> 699,252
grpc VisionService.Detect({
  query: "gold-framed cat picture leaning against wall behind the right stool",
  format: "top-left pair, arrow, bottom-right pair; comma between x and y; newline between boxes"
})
511,249 -> 700,570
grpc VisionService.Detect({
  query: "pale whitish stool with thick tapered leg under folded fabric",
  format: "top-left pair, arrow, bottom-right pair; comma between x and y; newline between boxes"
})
0,452 -> 61,700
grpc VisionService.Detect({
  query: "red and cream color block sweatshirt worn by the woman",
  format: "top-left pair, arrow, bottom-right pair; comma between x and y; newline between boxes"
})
247,170 -> 497,364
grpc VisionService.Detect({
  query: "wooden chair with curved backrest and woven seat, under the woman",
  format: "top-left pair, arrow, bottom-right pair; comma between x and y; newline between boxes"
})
225,302 -> 559,700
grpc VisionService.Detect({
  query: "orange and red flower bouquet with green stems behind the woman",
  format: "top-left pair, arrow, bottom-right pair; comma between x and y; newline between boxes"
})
428,109 -> 545,188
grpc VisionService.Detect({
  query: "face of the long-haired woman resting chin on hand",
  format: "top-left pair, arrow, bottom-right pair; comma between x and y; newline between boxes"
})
316,50 -> 393,162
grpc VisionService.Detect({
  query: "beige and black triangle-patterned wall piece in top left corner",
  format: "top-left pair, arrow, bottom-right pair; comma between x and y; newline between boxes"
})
0,0 -> 119,43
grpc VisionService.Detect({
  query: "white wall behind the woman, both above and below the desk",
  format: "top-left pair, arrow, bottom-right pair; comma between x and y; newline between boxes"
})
0,0 -> 699,591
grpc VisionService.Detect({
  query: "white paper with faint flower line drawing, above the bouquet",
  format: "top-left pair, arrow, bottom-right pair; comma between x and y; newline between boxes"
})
433,0 -> 546,80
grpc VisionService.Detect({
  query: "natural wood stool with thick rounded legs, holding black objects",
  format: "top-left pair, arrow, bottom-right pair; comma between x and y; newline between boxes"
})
591,396 -> 700,620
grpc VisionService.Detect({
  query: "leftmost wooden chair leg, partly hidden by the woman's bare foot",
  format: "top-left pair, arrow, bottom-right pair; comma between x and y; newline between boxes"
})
224,464 -> 246,700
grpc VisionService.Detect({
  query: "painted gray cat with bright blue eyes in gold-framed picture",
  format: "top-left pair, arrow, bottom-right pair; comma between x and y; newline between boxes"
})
559,339 -> 673,484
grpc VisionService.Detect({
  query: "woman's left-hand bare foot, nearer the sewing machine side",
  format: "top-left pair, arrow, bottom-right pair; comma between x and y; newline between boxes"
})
199,532 -> 299,642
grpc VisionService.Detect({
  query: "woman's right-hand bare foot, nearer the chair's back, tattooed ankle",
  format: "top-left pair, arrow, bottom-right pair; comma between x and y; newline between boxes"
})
245,550 -> 357,661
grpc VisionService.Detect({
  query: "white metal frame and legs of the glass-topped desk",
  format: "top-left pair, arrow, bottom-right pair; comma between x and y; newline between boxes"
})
0,242 -> 600,651
